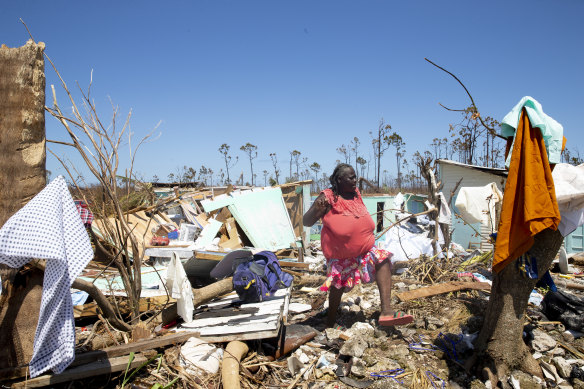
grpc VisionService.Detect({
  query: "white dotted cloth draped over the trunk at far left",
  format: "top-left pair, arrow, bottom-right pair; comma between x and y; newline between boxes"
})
0,176 -> 93,377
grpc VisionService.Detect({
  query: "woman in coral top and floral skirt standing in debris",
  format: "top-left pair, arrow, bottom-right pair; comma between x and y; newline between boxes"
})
303,163 -> 413,327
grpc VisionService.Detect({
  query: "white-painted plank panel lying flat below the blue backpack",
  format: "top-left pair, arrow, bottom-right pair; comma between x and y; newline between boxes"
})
177,288 -> 291,342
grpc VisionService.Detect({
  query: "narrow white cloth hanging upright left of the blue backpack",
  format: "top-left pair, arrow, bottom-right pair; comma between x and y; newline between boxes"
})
166,251 -> 195,323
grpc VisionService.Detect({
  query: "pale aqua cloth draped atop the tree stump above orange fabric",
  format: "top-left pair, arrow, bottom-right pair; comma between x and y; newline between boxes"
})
501,96 -> 564,167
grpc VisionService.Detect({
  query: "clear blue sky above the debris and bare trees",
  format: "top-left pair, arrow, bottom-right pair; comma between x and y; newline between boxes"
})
0,0 -> 584,184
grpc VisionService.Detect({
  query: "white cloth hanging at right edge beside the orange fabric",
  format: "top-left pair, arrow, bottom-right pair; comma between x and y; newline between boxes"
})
552,163 -> 584,236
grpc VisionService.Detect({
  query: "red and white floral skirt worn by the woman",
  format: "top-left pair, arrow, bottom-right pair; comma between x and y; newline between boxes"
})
320,245 -> 393,292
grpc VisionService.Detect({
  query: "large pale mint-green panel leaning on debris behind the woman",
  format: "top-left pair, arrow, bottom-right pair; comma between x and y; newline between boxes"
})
201,188 -> 297,251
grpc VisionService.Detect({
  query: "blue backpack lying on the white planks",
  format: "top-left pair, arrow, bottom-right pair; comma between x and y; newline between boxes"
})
233,251 -> 294,303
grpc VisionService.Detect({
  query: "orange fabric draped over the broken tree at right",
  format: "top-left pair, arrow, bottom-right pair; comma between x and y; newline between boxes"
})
493,109 -> 560,273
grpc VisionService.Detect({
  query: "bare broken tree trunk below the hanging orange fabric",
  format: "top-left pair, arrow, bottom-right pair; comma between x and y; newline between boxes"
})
467,229 -> 564,387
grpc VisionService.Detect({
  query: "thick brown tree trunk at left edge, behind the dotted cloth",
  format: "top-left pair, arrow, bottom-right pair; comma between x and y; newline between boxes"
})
0,41 -> 46,367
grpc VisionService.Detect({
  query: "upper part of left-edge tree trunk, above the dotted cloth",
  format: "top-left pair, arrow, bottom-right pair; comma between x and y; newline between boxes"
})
0,41 -> 46,226
